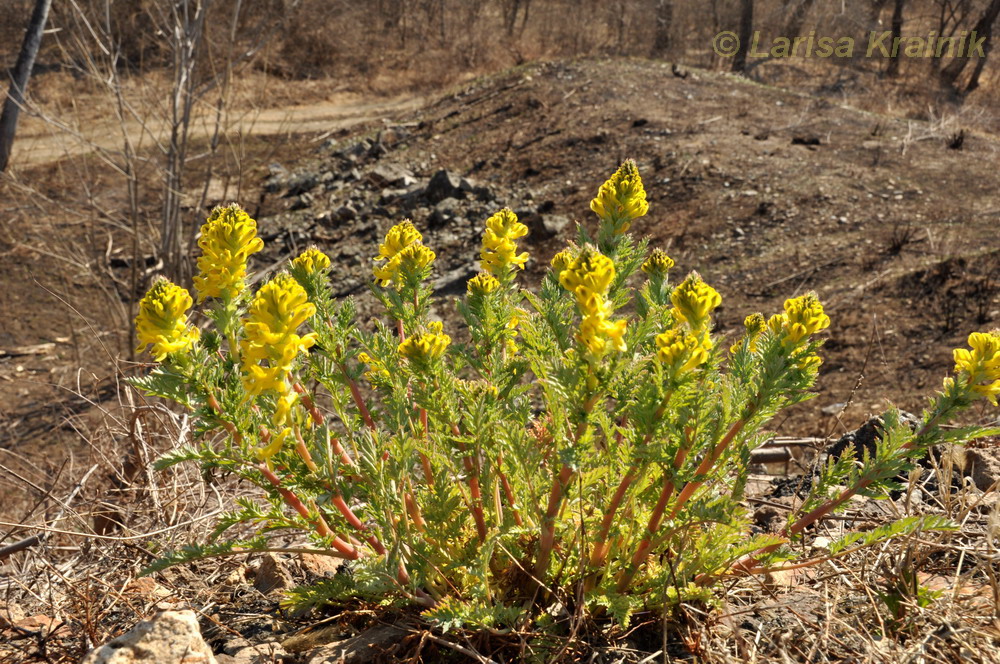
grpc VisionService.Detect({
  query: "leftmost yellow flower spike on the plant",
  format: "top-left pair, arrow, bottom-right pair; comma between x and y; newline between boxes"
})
135,278 -> 198,362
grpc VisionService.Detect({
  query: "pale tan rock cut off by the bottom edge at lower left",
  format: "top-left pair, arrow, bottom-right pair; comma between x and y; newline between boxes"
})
80,611 -> 217,664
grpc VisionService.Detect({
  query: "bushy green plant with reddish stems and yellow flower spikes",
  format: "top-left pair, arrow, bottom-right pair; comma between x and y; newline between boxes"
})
135,169 -> 1000,627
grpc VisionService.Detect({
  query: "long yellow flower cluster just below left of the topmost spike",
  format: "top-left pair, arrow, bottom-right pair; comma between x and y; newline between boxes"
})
559,246 -> 626,360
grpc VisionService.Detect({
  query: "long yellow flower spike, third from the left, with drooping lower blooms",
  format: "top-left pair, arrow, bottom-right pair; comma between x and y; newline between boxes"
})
240,274 -> 316,395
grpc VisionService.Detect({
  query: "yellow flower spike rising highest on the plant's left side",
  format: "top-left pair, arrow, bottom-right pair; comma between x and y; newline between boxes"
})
194,203 -> 264,302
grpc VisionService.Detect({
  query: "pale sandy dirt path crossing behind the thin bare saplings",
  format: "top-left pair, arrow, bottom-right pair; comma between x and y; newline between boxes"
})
11,94 -> 425,167
